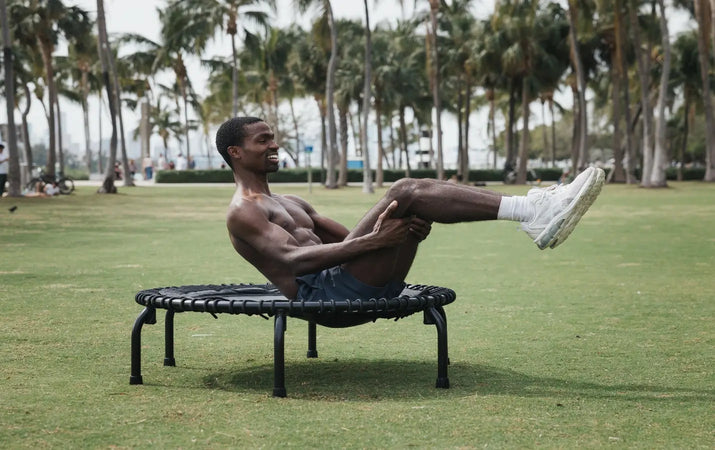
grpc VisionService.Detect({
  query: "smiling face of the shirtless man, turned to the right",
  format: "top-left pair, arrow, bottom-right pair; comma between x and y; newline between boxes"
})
232,122 -> 279,172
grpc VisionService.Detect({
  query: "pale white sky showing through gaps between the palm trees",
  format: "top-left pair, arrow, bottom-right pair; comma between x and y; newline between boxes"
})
0,0 -> 700,165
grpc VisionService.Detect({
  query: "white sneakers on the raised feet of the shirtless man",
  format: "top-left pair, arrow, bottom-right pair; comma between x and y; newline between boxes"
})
521,167 -> 605,250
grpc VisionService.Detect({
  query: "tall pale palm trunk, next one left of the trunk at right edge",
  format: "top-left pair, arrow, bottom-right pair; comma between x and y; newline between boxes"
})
650,0 -> 671,187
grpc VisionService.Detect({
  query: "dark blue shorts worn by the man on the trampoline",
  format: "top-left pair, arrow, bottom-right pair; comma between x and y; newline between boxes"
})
296,267 -> 405,301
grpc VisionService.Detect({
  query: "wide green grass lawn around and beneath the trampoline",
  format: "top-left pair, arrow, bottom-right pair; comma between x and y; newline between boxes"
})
0,183 -> 715,448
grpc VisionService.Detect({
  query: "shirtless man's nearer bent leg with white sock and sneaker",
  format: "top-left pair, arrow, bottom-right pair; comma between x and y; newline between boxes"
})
343,168 -> 604,286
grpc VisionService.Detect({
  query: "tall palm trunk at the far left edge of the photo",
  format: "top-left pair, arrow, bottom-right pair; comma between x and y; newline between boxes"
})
0,0 -> 19,197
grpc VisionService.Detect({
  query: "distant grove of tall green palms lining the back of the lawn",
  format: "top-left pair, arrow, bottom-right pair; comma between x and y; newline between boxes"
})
0,0 -> 715,196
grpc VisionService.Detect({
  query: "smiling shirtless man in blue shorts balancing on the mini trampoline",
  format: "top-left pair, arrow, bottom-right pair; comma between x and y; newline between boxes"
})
216,117 -> 604,301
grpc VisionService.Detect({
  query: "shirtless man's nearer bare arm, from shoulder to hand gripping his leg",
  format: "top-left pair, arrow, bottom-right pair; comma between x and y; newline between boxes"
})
232,202 -> 411,276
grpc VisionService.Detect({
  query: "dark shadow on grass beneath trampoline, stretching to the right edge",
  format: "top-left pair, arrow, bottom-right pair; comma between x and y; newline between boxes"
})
197,360 -> 715,404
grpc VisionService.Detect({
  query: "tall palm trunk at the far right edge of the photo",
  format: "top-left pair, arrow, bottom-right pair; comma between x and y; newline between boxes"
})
694,0 -> 715,181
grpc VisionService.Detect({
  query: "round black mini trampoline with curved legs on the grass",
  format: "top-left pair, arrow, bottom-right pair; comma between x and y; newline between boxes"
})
129,284 -> 456,397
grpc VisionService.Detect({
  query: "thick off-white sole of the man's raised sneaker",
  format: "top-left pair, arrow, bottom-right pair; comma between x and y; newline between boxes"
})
534,169 -> 606,250
